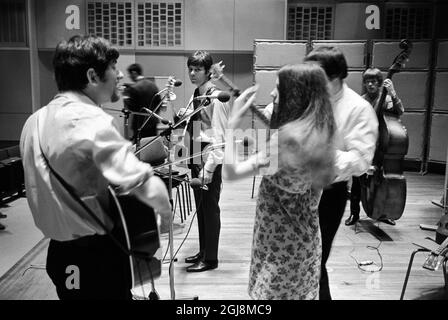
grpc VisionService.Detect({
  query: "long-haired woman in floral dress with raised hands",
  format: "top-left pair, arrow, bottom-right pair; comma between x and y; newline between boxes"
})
223,64 -> 335,300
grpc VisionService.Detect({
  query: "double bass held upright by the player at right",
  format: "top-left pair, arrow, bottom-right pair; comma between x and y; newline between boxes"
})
360,40 -> 412,220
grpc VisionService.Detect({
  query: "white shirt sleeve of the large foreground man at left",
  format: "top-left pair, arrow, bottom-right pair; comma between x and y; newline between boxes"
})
93,116 -> 153,194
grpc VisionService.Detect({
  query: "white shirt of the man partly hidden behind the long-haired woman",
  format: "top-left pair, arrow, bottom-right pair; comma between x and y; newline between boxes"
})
331,83 -> 378,182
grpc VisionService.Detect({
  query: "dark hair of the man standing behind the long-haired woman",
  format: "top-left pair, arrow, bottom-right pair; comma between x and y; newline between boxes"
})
304,46 -> 347,80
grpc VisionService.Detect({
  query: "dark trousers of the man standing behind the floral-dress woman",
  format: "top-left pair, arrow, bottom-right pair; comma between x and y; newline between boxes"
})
319,182 -> 347,300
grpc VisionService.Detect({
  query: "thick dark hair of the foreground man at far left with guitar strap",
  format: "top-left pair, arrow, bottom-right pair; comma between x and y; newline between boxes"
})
53,35 -> 120,91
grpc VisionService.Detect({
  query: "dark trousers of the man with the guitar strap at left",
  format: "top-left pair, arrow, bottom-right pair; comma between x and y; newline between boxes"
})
47,235 -> 132,300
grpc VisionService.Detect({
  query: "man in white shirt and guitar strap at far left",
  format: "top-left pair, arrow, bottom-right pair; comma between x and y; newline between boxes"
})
20,36 -> 171,299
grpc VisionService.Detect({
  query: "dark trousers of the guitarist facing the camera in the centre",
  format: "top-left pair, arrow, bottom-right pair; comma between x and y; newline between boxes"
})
191,165 -> 222,262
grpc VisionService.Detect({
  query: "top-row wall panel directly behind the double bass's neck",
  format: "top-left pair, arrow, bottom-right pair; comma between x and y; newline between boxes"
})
372,41 -> 430,69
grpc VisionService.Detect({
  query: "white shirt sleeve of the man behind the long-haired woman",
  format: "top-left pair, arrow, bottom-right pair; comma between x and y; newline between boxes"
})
335,103 -> 378,182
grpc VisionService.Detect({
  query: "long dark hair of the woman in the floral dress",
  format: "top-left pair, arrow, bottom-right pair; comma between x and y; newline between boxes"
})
272,63 -> 336,188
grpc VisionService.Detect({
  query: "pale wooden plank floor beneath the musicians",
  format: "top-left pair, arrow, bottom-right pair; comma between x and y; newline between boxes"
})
0,172 -> 448,300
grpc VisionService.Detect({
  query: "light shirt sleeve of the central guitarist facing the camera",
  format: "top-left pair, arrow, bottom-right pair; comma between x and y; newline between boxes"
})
204,99 -> 229,172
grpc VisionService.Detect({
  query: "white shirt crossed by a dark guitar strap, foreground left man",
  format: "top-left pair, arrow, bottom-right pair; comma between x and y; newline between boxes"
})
20,92 -> 153,241
